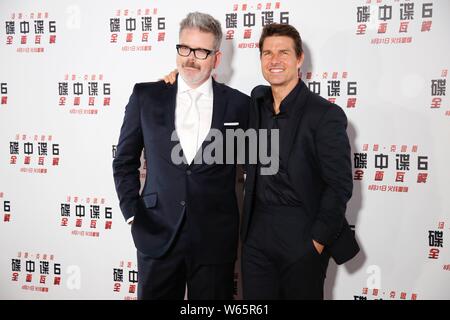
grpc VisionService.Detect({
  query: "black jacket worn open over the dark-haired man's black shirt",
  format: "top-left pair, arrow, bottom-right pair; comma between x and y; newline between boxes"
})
241,81 -> 359,264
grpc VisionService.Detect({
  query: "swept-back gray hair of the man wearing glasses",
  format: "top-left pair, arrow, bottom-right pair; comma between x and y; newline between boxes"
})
180,12 -> 222,50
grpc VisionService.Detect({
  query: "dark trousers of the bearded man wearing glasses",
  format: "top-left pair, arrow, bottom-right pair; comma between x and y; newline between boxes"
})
137,218 -> 234,300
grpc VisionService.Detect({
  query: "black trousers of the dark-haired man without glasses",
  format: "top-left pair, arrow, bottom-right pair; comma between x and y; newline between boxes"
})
242,207 -> 330,300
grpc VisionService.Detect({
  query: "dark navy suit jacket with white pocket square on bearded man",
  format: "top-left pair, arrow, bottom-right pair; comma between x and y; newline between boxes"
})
113,81 -> 250,264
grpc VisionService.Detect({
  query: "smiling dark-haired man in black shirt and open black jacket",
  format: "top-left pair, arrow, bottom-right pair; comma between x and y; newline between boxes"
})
241,24 -> 359,299
